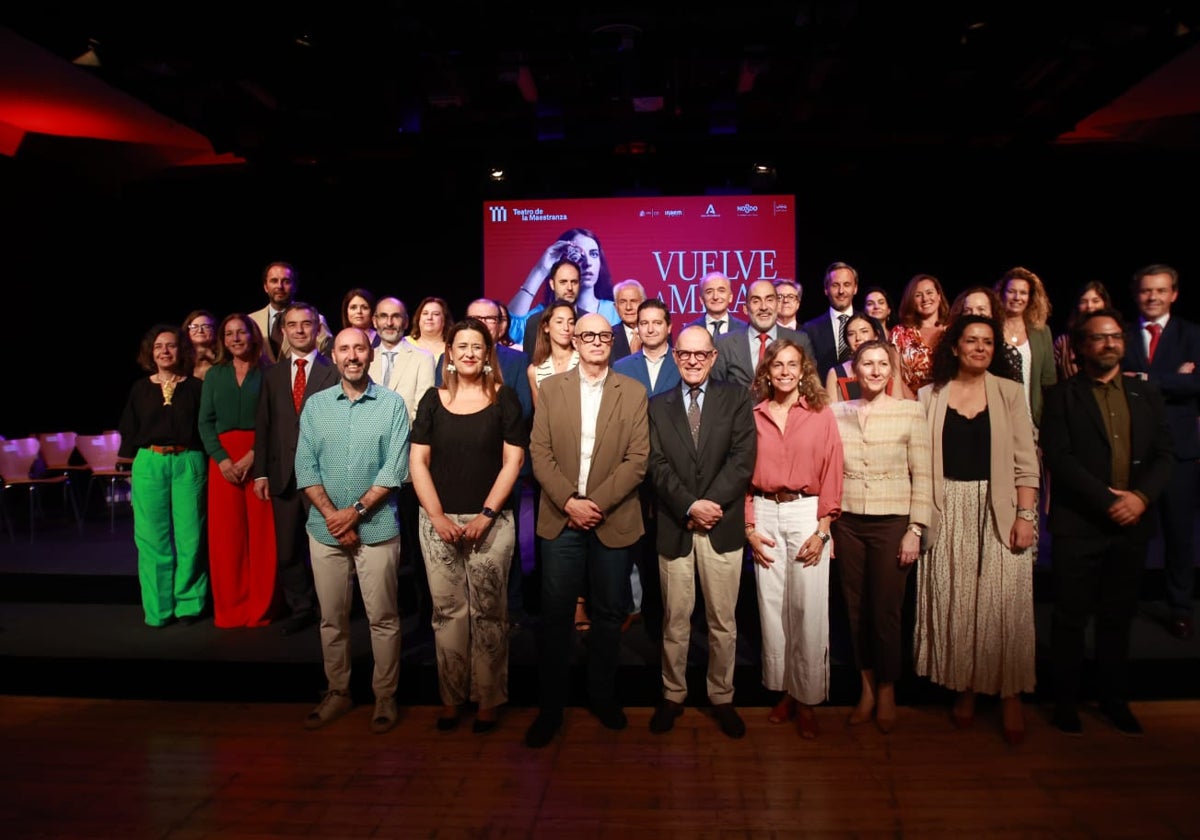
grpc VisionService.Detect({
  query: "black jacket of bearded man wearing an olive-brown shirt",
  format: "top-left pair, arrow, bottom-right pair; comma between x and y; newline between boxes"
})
1038,369 -> 1175,540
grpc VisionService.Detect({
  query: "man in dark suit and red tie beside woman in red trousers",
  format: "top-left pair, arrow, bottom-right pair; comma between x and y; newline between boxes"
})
254,302 -> 338,636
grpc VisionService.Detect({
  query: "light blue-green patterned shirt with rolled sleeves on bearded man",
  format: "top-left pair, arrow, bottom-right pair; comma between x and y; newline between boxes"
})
295,382 -> 409,546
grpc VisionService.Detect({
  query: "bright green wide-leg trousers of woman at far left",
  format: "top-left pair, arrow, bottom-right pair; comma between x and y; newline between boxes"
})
130,449 -> 209,628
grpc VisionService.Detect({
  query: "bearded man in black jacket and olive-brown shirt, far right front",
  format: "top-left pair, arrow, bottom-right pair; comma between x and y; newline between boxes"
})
1039,308 -> 1175,734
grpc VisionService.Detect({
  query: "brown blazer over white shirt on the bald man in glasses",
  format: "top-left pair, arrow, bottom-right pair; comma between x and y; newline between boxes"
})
529,368 -> 650,548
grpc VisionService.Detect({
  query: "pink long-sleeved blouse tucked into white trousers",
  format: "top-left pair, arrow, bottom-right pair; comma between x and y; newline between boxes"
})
745,397 -> 842,524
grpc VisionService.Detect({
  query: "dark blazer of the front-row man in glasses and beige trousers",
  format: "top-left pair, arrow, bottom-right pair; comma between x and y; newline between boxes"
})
648,378 -> 758,557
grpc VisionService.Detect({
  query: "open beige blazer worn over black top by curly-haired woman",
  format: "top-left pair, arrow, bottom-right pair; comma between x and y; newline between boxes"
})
917,373 -> 1039,545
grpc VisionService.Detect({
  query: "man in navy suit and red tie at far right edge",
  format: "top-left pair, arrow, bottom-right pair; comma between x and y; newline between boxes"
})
1122,264 -> 1200,640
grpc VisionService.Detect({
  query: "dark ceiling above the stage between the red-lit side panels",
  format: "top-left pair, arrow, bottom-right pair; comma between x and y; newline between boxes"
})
4,0 -> 1200,180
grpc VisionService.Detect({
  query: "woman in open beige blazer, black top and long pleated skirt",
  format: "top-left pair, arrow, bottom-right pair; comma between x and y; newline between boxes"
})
914,316 -> 1038,744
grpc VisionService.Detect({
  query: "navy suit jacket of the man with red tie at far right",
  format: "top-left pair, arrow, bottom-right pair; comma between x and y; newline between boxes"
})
1121,314 -> 1200,461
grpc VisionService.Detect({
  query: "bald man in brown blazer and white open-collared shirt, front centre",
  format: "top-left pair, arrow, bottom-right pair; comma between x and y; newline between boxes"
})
526,313 -> 650,748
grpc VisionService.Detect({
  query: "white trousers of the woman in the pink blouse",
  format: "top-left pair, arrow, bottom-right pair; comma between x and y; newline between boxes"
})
754,496 -> 829,706
